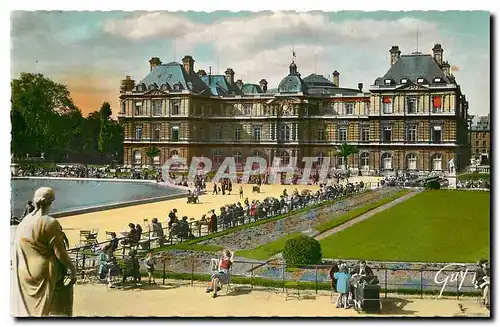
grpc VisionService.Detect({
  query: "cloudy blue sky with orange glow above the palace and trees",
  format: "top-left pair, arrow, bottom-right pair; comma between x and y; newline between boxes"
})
11,11 -> 490,115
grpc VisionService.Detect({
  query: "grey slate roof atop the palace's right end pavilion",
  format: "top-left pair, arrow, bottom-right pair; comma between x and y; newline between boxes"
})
375,54 -> 453,86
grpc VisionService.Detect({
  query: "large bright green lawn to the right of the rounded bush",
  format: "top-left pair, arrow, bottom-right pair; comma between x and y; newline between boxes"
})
320,190 -> 490,262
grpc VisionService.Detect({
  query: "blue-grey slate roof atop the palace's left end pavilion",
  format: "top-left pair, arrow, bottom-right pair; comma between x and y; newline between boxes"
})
138,62 -> 209,95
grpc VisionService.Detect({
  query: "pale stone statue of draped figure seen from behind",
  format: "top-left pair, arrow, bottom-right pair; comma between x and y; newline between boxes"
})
13,187 -> 76,317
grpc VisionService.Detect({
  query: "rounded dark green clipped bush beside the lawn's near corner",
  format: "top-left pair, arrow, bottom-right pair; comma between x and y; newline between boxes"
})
283,234 -> 322,265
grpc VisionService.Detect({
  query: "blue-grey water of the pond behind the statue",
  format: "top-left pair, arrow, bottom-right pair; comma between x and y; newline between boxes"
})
10,179 -> 183,216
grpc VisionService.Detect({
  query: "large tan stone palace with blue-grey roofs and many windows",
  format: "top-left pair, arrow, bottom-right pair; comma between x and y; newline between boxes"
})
118,44 -> 470,174
